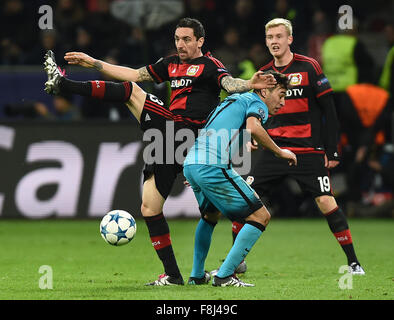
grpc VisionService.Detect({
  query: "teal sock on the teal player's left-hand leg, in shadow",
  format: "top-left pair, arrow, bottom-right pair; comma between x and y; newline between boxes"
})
191,219 -> 216,278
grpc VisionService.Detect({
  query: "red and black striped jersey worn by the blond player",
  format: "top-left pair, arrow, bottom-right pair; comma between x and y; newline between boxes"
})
260,53 -> 332,153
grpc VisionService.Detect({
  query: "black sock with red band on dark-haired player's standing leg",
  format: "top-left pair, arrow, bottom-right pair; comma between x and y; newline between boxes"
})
144,213 -> 181,278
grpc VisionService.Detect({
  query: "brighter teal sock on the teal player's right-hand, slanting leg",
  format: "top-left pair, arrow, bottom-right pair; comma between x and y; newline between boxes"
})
217,223 -> 263,278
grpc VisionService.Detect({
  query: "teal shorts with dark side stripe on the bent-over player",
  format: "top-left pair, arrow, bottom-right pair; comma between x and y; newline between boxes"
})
183,164 -> 263,221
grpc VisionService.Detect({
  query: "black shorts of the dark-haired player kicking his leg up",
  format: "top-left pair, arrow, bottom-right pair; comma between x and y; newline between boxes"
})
140,94 -> 202,199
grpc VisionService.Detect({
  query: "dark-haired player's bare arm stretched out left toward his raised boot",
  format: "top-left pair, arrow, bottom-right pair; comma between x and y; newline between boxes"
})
64,52 -> 153,82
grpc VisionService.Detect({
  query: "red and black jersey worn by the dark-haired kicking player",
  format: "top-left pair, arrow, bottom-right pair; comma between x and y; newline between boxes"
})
147,52 -> 230,123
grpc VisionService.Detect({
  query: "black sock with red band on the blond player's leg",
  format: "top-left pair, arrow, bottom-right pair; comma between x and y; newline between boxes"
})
324,207 -> 359,265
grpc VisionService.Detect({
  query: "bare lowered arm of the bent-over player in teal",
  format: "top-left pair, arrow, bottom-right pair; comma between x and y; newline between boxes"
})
246,117 -> 297,166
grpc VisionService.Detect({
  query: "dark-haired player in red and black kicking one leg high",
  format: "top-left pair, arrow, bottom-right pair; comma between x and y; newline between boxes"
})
44,18 -> 276,286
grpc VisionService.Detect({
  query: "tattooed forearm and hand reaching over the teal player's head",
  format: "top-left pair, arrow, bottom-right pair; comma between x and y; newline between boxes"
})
222,71 -> 276,94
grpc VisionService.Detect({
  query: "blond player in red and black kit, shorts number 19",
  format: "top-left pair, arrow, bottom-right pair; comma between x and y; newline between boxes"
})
229,18 -> 365,274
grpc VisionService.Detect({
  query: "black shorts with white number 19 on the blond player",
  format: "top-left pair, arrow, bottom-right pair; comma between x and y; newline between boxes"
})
246,150 -> 332,198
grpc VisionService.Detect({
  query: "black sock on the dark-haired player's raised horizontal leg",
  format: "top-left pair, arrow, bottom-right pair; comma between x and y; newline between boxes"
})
59,77 -> 133,102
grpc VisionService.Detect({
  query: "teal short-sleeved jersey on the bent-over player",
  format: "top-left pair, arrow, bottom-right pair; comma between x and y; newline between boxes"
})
184,92 -> 268,168
